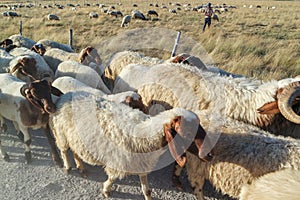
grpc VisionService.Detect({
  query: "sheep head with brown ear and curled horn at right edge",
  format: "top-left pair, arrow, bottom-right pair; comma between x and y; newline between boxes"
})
257,81 -> 300,124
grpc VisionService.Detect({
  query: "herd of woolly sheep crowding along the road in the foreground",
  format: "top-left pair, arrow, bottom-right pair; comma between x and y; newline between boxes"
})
0,30 -> 300,199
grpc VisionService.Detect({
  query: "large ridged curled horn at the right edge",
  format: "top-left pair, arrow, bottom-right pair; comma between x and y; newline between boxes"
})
278,81 -> 300,124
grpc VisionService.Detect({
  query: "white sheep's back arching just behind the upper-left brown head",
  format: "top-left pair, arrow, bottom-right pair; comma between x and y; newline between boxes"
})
9,47 -> 54,79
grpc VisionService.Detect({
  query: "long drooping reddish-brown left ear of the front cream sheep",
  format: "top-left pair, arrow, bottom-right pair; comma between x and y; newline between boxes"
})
164,120 -> 186,167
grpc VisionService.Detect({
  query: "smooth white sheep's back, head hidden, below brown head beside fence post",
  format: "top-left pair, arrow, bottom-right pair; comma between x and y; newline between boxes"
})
55,61 -> 111,94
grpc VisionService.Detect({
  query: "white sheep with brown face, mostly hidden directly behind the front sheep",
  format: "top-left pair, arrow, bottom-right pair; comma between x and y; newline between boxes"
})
52,76 -> 146,113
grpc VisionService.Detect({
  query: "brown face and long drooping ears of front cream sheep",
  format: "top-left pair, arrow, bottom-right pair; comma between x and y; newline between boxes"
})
164,116 -> 213,167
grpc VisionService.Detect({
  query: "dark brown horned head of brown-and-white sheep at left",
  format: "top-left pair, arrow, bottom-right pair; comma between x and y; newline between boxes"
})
20,79 -> 62,114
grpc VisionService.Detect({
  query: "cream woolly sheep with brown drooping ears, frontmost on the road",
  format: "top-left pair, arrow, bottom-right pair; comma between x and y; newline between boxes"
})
50,92 -> 211,199
